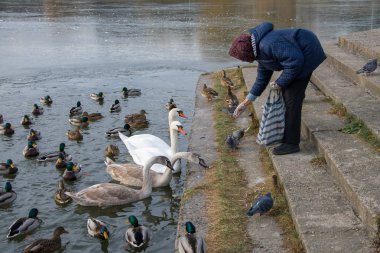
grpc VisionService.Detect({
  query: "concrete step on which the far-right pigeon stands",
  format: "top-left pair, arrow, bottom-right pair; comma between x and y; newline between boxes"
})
323,43 -> 380,97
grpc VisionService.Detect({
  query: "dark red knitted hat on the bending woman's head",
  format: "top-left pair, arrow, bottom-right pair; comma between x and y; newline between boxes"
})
228,34 -> 255,62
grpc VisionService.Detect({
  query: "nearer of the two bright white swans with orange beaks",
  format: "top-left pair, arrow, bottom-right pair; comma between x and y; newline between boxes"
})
119,121 -> 186,173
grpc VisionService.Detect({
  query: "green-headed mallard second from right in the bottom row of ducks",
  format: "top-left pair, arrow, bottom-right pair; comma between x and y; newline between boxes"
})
125,215 -> 152,248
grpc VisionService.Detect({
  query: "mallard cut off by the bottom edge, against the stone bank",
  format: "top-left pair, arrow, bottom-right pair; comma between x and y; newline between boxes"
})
177,221 -> 206,253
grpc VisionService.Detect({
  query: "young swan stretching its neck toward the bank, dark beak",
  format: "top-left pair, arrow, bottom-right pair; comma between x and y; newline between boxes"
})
105,152 -> 208,187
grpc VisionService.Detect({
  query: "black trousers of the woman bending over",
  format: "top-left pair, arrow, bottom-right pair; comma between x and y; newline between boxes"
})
282,74 -> 311,145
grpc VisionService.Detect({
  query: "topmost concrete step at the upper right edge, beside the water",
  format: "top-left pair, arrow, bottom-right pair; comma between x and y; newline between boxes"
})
338,28 -> 380,59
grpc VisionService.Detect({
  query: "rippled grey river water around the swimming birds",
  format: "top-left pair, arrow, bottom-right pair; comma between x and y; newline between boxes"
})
0,0 -> 380,253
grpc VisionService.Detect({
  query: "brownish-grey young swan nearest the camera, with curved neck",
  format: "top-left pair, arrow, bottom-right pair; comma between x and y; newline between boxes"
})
65,156 -> 173,207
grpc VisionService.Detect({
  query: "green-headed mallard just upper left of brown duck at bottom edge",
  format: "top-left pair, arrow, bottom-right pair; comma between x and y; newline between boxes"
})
7,208 -> 42,239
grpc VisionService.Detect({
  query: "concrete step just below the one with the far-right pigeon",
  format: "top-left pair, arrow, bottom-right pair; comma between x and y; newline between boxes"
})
311,62 -> 380,138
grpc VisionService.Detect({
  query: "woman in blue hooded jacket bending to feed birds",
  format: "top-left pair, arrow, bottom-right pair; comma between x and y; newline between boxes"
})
229,22 -> 326,155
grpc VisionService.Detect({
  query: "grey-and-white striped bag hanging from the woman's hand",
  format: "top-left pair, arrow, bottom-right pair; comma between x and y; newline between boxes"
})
256,89 -> 285,145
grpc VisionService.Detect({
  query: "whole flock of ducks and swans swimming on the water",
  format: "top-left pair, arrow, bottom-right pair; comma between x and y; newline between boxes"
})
0,87 -> 208,252
